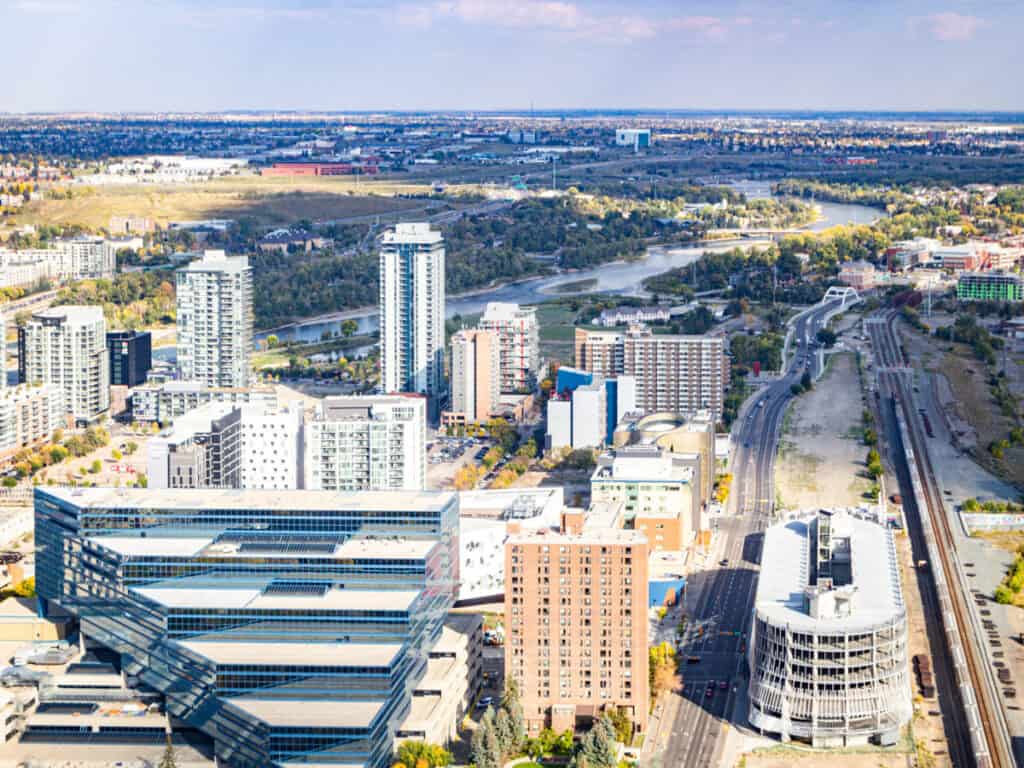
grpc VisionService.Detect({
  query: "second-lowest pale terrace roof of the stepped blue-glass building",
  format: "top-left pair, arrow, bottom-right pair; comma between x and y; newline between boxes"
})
178,638 -> 401,667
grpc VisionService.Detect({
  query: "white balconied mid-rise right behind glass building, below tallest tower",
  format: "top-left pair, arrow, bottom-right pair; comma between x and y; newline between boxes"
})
304,395 -> 427,490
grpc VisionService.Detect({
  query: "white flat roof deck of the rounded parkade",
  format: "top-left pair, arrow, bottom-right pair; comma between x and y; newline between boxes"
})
755,512 -> 905,632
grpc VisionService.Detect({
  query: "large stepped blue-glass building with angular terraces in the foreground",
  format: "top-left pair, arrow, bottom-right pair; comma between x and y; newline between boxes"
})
35,488 -> 458,768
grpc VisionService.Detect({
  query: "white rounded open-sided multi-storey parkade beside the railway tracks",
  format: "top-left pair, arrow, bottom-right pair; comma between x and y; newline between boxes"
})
748,510 -> 911,746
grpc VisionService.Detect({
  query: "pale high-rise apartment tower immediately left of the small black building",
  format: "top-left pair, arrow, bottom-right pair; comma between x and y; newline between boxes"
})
17,306 -> 111,423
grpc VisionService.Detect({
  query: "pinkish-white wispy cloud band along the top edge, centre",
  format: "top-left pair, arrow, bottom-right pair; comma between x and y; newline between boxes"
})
396,0 -> 753,43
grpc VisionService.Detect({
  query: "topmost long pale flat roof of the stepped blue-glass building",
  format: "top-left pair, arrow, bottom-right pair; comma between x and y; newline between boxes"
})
36,487 -> 456,512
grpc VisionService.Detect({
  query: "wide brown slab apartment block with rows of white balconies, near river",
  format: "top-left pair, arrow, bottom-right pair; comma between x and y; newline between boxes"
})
575,327 -> 729,421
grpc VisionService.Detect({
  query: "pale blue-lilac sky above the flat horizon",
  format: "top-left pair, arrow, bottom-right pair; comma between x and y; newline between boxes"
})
0,0 -> 1024,112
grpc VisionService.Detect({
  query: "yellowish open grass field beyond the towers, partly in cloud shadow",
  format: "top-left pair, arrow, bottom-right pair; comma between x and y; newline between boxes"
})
17,176 -> 456,228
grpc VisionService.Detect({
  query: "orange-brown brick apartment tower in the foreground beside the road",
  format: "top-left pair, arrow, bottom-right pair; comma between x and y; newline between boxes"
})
505,504 -> 649,736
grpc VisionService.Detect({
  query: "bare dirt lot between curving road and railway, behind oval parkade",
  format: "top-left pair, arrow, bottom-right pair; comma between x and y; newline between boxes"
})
775,354 -> 871,509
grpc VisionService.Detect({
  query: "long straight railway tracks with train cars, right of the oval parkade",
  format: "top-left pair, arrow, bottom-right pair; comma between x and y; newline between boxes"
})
871,313 -> 1016,768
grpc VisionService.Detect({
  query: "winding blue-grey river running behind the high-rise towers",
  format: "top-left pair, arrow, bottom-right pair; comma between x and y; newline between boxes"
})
256,195 -> 885,348
